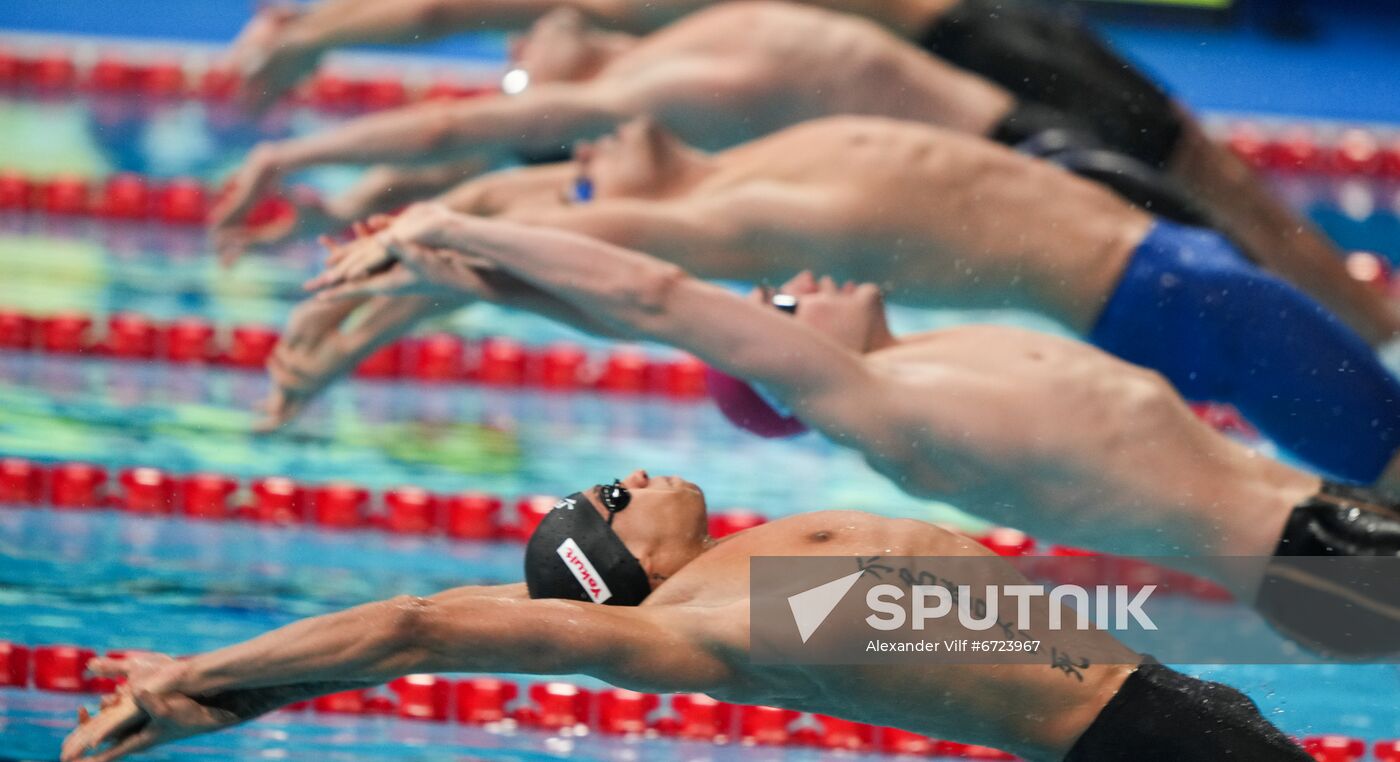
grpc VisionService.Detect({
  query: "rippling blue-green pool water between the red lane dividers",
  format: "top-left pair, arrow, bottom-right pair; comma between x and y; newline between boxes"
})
0,40 -> 1400,761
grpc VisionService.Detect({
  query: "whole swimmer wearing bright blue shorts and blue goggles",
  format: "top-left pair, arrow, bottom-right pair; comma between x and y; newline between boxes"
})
274,116 -> 1400,487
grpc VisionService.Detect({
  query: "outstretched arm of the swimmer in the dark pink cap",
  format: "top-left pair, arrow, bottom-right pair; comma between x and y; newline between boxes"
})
358,207 -> 918,455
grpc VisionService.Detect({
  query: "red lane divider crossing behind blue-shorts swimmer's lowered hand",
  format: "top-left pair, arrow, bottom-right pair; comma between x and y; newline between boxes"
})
0,308 -> 707,401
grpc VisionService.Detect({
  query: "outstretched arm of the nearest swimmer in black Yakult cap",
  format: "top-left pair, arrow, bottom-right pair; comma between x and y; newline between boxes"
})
140,594 -> 728,696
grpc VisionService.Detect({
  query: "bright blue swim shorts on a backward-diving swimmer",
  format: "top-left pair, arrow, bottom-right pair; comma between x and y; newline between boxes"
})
1091,223 -> 1400,485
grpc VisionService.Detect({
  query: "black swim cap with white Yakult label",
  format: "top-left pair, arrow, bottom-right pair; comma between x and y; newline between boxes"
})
525,492 -> 651,607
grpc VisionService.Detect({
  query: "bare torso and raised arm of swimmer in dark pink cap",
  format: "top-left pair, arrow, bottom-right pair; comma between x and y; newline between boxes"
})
316,206 -> 1320,579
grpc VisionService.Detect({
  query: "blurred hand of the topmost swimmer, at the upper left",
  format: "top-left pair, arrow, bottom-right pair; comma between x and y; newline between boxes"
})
227,6 -> 321,113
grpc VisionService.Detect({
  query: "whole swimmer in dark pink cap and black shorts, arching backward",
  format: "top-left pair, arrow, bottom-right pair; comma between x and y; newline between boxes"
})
306,214 -> 1400,657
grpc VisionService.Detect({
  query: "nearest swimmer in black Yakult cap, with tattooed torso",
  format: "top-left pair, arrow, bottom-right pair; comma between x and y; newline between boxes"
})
62,472 -> 1308,762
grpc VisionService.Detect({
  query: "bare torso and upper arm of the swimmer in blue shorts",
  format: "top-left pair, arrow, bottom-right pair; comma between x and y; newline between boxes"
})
487,116 -> 1152,331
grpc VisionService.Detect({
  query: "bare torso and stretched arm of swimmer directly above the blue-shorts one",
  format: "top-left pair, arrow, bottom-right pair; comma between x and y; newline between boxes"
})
214,3 -> 1014,249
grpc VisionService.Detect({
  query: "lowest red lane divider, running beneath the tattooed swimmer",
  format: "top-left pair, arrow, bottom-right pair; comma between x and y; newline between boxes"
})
0,640 -> 1400,762
